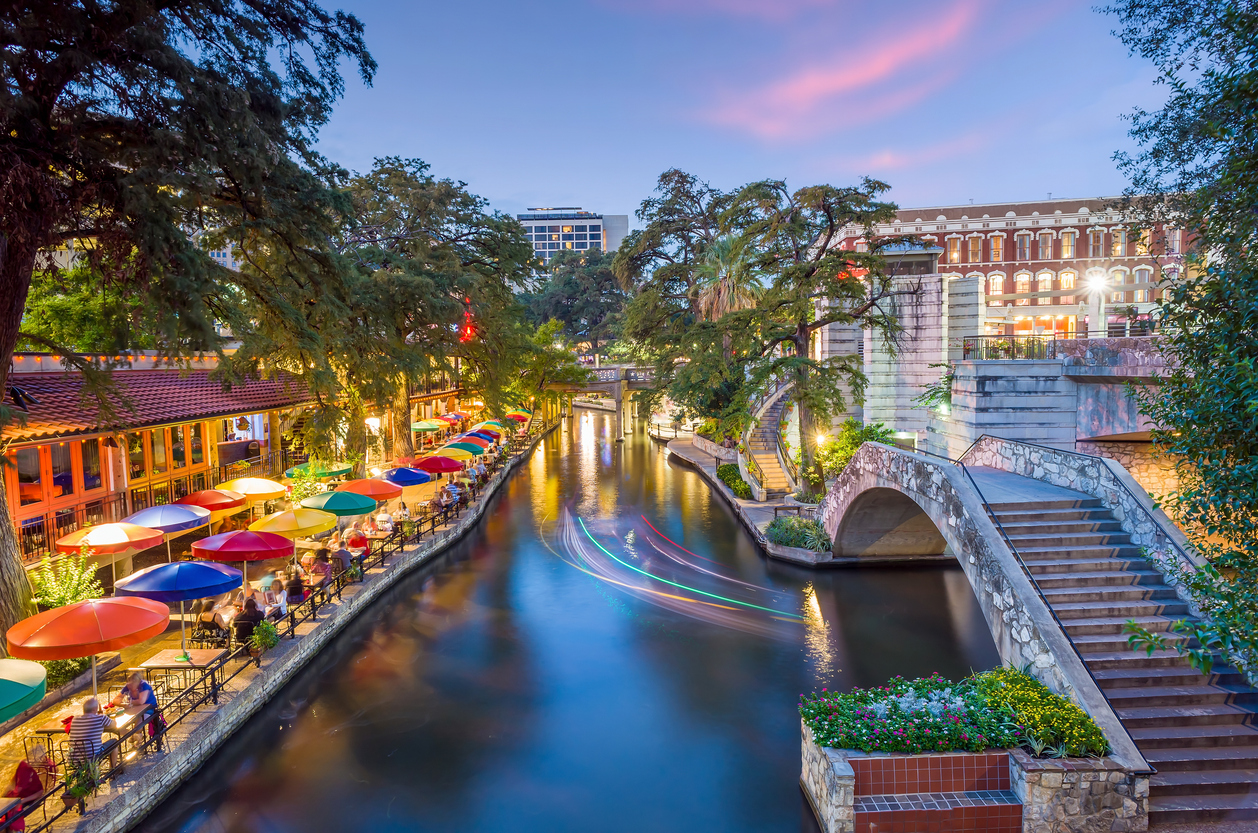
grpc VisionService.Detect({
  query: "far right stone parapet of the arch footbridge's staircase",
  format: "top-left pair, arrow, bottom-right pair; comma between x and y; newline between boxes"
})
961,437 -> 1200,615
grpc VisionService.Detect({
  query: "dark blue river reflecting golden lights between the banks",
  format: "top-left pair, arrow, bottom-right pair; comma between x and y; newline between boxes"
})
140,410 -> 998,833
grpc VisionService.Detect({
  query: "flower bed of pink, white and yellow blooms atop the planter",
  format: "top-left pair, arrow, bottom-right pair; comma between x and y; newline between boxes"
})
799,668 -> 1108,758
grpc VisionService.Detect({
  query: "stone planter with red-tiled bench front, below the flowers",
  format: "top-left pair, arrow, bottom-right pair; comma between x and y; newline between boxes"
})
800,721 -> 1149,833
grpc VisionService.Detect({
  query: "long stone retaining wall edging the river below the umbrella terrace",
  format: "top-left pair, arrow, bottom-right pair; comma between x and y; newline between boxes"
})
81,423 -> 559,833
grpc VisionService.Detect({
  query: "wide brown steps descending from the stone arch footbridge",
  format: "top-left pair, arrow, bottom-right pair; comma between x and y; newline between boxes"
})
984,490 -> 1258,829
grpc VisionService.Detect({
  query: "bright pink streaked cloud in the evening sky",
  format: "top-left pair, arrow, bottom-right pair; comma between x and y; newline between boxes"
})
703,0 -> 979,140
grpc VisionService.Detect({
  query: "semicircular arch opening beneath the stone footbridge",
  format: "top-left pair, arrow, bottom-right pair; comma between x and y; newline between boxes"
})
834,488 -> 951,557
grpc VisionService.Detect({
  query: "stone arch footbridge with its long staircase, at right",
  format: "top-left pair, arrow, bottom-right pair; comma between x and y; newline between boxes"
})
818,435 -> 1258,829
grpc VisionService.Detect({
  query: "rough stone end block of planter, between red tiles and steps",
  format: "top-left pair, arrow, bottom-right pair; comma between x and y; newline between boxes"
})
1009,749 -> 1149,833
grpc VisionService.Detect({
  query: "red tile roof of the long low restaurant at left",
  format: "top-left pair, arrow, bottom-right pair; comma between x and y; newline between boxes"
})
3,369 -> 313,443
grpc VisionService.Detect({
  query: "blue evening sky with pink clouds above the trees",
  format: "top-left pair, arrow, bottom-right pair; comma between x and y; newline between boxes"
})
321,0 -> 1161,225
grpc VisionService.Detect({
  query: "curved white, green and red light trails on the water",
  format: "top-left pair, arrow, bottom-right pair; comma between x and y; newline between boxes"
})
551,508 -> 805,640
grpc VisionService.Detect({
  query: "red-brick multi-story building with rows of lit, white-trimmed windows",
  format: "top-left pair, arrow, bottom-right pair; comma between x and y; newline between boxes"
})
847,198 -> 1185,336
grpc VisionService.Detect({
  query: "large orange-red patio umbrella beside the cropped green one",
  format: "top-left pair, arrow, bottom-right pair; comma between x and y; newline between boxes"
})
5,596 -> 170,697
